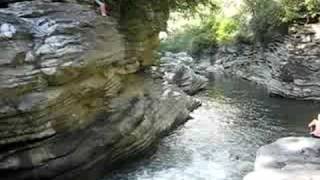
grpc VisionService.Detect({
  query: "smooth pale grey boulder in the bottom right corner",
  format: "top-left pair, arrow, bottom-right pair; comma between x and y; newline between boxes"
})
244,137 -> 320,180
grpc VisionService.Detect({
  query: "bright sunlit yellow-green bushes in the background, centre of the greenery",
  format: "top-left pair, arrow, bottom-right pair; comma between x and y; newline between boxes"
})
160,1 -> 240,54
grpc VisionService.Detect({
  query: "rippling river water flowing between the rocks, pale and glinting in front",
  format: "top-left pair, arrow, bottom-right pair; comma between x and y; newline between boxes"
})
104,75 -> 320,180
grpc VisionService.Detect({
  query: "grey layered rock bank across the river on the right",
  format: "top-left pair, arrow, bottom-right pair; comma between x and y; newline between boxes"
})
204,24 -> 320,100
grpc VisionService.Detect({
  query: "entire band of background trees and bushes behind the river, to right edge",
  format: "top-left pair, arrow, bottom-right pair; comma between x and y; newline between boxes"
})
161,0 -> 320,53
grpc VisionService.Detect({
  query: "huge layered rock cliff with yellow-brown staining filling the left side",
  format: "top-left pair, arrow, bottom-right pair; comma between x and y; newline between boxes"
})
0,1 -> 199,180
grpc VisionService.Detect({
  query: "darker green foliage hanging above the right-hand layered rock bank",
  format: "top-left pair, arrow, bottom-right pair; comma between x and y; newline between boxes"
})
244,0 -> 320,42
